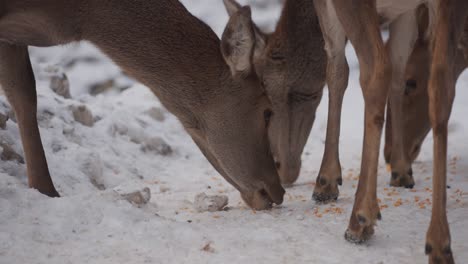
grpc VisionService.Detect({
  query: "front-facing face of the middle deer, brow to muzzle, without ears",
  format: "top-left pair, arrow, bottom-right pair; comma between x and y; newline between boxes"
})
256,54 -> 324,184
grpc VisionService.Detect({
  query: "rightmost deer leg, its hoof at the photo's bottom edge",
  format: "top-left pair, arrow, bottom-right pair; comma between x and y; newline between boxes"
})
426,0 -> 468,264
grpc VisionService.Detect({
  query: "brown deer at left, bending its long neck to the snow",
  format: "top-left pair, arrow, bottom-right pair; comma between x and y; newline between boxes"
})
0,0 -> 284,209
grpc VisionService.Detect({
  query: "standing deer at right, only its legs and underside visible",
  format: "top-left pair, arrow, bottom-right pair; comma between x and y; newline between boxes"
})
314,0 -> 468,264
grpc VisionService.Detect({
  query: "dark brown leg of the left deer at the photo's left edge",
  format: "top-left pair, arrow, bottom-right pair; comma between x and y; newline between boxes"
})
0,43 -> 59,197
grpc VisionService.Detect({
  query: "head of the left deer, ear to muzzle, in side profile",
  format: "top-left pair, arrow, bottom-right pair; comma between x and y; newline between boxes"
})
186,3 -> 284,209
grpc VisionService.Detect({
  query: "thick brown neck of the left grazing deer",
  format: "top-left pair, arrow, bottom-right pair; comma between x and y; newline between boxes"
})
83,0 -> 230,119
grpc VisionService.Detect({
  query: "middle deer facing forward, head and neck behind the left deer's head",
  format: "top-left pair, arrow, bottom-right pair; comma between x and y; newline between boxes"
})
224,0 -> 326,184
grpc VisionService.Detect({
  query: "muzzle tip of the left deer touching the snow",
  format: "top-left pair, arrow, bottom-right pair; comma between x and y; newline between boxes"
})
241,186 -> 285,210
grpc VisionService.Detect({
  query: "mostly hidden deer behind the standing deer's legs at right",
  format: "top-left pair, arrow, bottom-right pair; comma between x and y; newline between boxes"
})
384,6 -> 468,173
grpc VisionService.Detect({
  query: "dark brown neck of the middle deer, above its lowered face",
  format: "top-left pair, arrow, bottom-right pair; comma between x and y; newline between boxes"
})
267,0 -> 327,90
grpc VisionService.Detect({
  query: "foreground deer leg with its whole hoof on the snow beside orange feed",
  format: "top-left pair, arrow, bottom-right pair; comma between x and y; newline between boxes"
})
333,0 -> 391,243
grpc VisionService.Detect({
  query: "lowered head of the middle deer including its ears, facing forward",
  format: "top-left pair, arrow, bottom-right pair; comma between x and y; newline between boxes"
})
224,0 -> 326,184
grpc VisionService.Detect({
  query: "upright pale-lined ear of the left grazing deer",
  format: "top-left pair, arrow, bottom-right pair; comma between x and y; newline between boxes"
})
221,6 -> 255,75
